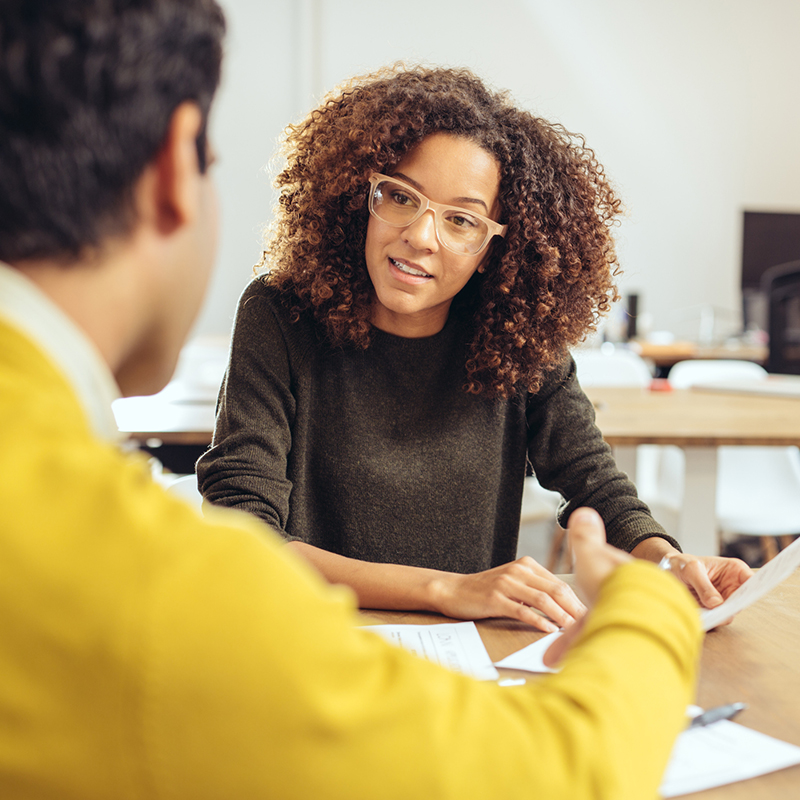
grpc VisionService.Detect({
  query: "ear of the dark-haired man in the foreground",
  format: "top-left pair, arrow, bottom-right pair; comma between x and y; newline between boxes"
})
137,102 -> 203,234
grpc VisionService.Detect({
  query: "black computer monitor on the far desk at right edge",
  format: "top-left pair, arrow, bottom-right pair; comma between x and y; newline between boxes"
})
741,211 -> 800,330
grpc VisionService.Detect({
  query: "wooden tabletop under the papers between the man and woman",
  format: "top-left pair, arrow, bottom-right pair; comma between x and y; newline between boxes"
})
362,571 -> 800,800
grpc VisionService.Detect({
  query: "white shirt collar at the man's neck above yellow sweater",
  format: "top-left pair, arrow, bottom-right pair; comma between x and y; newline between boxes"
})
0,261 -> 120,441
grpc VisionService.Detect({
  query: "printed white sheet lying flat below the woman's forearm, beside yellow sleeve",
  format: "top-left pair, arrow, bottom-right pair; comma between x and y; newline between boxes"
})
364,622 -> 500,681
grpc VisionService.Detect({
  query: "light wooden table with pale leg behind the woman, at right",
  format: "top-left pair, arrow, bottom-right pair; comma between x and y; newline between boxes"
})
586,387 -> 800,555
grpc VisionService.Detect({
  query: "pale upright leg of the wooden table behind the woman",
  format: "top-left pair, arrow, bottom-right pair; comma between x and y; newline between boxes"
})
677,447 -> 719,556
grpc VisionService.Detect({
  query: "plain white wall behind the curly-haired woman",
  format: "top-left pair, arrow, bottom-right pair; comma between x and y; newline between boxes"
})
197,0 -> 800,337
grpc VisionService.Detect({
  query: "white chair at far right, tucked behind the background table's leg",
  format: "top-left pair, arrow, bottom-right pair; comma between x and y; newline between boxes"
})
659,360 -> 800,561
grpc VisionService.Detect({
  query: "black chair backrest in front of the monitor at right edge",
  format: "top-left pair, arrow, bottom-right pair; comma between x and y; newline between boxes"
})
761,261 -> 800,375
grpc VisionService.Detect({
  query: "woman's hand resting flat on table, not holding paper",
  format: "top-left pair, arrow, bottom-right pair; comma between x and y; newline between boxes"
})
424,556 -> 586,633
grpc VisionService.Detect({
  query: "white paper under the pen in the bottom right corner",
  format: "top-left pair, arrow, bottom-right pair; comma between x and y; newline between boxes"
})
660,709 -> 800,797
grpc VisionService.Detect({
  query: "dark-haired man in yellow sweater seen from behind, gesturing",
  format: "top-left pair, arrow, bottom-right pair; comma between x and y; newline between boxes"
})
0,0 -> 701,800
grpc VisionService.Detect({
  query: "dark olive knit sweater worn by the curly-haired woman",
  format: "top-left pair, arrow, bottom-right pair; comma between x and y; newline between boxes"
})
197,280 -> 675,572
